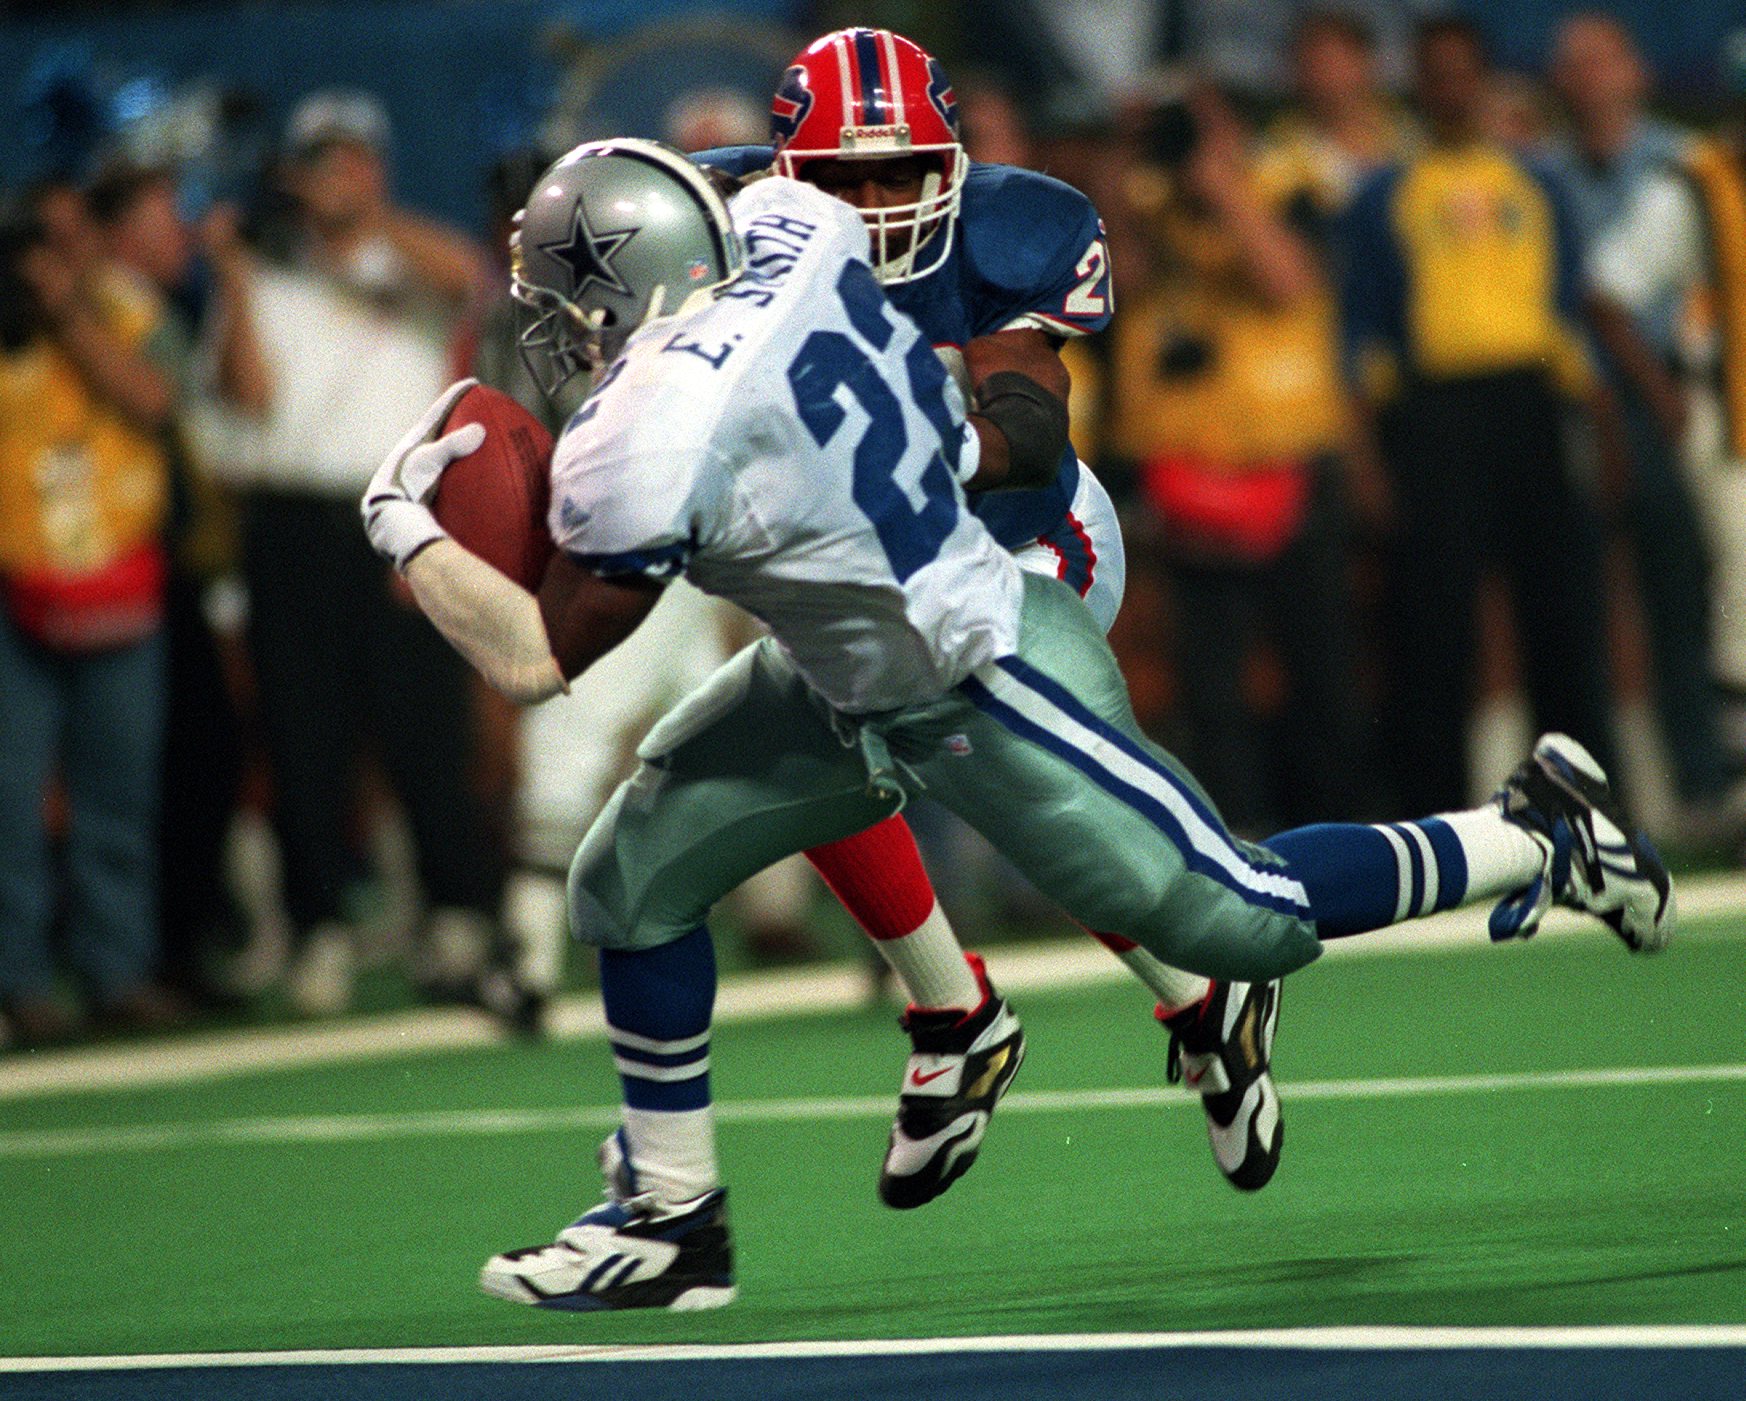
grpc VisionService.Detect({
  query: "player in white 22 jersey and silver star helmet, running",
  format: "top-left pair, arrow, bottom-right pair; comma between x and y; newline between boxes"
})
363,141 -> 1673,1310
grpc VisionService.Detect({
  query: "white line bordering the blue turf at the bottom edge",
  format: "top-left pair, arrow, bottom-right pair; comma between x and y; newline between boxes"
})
0,1324 -> 1746,1373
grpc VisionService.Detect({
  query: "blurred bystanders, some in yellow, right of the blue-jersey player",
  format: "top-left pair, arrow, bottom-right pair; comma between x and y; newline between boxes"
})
1100,10 -> 1746,845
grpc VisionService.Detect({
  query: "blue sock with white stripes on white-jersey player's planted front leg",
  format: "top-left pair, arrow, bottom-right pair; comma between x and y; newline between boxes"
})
601,928 -> 716,1111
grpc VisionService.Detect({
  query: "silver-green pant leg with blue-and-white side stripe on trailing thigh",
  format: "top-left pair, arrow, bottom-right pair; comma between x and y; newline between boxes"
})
921,573 -> 1320,982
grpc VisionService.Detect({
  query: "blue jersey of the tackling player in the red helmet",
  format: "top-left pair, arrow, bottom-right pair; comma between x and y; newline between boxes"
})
691,147 -> 1112,550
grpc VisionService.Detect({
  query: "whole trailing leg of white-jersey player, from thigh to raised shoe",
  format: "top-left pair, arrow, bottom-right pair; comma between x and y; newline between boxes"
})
894,565 -> 1671,980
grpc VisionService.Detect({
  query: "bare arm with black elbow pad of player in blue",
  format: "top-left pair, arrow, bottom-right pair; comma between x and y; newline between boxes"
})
964,328 -> 1072,491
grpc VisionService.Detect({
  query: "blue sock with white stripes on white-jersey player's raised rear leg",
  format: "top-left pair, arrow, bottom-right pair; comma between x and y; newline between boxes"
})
1262,818 -> 1467,938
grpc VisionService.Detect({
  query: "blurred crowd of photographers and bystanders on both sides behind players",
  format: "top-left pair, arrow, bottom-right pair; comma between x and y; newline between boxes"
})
0,9 -> 1746,1045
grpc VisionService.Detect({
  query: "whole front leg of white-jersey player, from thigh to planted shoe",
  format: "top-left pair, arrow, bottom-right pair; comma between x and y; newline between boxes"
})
480,643 -> 894,1310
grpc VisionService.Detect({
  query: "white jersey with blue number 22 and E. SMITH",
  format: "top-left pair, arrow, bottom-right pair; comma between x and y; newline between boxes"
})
550,178 -> 1023,713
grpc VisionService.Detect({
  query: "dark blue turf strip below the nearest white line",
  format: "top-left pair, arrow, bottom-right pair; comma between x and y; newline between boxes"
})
10,1347 -> 1746,1401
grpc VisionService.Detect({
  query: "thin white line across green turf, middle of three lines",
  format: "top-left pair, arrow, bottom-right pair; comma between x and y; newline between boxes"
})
0,1064 -> 1746,1160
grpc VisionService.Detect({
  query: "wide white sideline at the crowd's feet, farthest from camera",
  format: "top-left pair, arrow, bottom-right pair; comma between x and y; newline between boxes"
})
0,873 -> 1746,1101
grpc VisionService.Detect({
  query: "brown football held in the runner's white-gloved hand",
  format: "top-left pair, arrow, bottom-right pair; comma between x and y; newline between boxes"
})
431,384 -> 557,592
